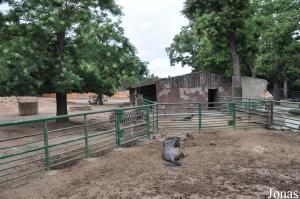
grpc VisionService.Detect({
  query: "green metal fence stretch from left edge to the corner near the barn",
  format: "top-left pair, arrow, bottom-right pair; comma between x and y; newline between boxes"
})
0,105 -> 157,184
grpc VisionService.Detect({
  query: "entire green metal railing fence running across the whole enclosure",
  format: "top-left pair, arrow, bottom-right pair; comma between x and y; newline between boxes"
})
0,98 -> 300,184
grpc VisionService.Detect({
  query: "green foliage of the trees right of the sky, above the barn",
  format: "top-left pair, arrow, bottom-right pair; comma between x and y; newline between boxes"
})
166,0 -> 300,91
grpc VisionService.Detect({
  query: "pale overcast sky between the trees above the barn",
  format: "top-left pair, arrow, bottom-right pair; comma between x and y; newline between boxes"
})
117,0 -> 191,77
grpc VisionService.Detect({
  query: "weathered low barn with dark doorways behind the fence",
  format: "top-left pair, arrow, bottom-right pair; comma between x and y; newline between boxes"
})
128,72 -> 267,104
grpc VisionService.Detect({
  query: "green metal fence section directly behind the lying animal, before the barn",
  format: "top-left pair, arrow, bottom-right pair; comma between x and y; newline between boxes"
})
158,101 -> 270,130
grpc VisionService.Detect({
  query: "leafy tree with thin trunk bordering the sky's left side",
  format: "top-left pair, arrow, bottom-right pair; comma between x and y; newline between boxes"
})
74,19 -> 147,104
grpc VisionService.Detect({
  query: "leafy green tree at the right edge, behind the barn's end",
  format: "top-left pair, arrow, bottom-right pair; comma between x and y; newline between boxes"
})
255,0 -> 300,100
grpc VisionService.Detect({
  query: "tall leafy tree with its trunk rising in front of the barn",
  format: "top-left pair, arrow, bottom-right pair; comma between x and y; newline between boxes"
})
167,0 -> 250,96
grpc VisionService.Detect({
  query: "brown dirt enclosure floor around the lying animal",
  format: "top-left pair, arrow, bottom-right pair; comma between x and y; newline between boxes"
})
0,129 -> 300,199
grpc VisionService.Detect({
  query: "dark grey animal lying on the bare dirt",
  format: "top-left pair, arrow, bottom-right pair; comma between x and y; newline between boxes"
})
162,136 -> 184,166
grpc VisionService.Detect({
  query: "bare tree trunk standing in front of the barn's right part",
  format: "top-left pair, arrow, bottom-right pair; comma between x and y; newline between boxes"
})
229,33 -> 242,97
